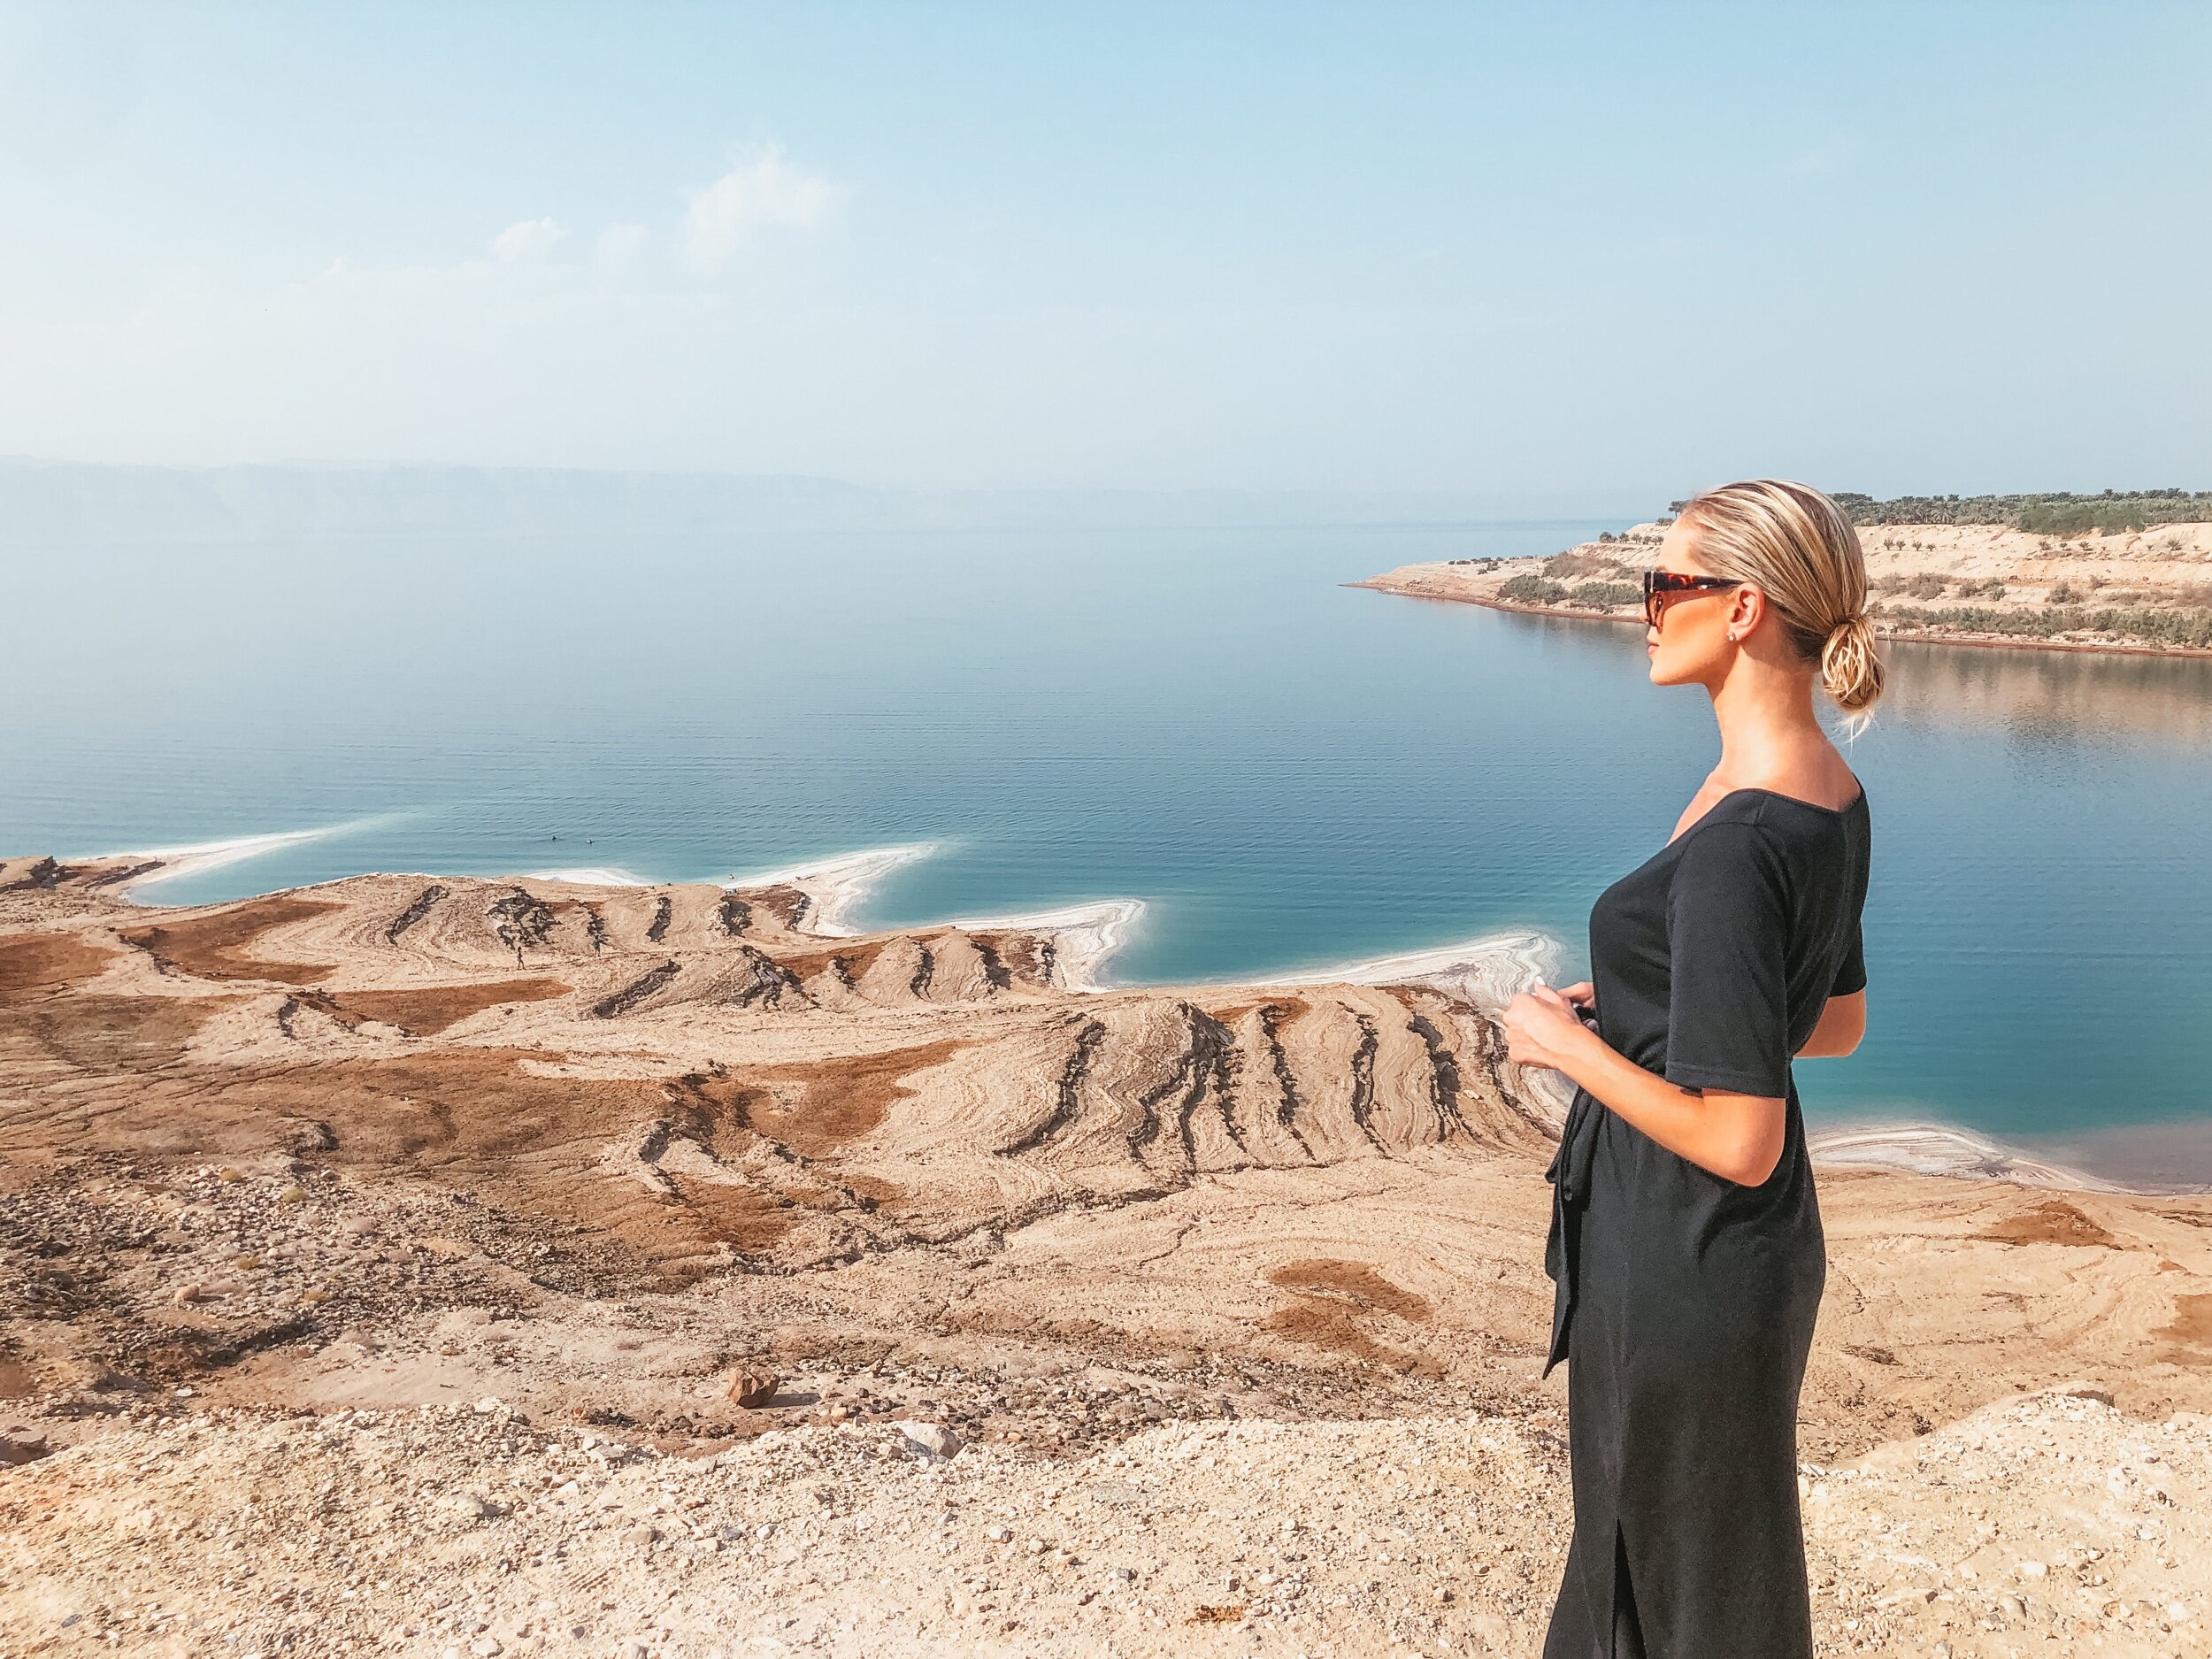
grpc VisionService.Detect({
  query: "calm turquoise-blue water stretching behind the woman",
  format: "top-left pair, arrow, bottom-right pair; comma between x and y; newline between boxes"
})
0,522 -> 2212,1179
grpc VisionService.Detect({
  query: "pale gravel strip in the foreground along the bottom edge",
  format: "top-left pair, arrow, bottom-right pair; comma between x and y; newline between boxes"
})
0,1394 -> 2212,1659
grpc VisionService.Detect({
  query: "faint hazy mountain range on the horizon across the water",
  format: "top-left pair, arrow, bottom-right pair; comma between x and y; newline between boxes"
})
0,458 -> 1632,544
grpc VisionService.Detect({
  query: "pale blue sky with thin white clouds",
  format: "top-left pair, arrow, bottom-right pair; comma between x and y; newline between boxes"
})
0,0 -> 2212,511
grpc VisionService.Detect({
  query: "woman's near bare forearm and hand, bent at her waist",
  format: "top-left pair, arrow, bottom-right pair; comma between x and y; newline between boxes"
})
1500,985 -> 1787,1186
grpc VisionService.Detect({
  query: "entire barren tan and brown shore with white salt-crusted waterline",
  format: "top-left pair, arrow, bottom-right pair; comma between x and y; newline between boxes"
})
0,854 -> 2212,1657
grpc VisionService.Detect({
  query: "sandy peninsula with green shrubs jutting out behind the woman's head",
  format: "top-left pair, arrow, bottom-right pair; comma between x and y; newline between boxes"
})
1352,491 -> 2212,655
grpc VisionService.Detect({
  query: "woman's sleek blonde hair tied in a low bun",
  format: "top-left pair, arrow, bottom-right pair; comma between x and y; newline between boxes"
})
1681,478 -> 1883,726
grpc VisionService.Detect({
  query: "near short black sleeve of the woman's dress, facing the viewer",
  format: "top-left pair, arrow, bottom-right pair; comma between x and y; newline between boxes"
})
1666,823 -> 1790,1100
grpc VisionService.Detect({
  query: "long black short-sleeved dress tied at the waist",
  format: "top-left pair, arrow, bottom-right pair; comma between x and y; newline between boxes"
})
1544,790 -> 1870,1659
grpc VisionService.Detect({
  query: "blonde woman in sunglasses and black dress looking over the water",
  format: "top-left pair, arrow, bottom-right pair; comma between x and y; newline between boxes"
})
1504,480 -> 1883,1659
